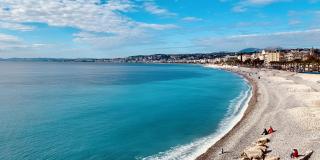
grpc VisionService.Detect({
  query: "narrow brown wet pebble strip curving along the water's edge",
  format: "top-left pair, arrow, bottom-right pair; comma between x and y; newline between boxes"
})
196,65 -> 258,160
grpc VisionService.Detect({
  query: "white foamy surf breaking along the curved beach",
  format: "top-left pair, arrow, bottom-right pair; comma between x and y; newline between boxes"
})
141,82 -> 252,160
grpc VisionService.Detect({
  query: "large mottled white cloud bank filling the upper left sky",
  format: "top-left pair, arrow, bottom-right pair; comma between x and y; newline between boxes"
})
0,0 -> 176,47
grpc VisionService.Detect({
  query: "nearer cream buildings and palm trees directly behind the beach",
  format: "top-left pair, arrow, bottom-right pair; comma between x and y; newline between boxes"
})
208,48 -> 320,72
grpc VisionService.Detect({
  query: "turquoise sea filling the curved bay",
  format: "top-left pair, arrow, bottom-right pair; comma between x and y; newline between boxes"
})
0,62 -> 249,160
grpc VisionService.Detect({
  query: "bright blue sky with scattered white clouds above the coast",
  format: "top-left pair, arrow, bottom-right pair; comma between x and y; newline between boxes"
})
0,0 -> 320,58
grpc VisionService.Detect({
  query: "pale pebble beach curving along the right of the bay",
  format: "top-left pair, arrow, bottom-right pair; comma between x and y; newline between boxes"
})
197,66 -> 320,160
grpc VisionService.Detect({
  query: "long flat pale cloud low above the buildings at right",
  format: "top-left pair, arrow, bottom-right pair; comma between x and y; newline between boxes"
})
196,29 -> 320,51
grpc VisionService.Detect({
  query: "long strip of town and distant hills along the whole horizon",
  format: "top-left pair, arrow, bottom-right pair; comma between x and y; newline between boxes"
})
0,48 -> 320,72
